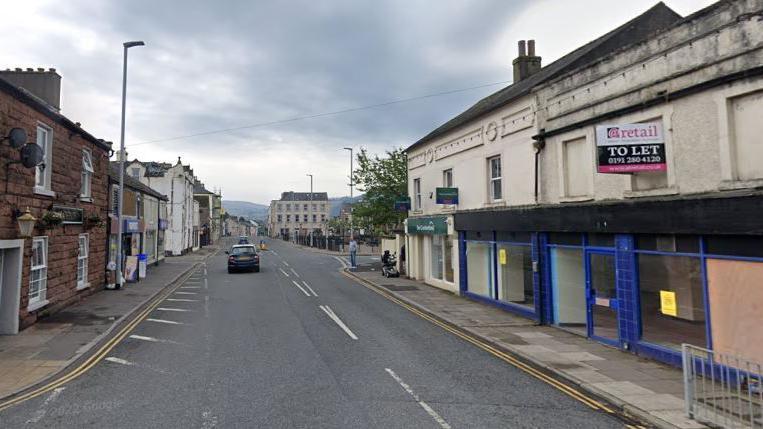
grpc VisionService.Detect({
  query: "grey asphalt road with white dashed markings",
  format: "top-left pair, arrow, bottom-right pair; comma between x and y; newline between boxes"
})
0,240 -> 623,428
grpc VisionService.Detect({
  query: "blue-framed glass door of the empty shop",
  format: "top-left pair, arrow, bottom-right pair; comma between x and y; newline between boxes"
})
586,251 -> 620,346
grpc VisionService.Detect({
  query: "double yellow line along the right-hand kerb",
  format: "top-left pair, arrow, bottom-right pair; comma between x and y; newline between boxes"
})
342,270 -> 624,414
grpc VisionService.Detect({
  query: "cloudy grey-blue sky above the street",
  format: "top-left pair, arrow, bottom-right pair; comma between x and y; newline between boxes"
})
0,0 -> 713,204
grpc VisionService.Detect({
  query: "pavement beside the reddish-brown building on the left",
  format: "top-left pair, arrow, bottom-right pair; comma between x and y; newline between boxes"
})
0,246 -> 218,399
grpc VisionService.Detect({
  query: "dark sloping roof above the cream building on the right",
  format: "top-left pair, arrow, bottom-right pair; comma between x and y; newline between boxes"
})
406,2 -> 682,152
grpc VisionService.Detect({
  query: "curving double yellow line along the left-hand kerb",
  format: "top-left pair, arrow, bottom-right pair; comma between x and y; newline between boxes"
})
0,260 -> 199,411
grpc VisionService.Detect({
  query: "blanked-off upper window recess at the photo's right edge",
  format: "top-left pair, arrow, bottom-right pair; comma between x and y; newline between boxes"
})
729,91 -> 763,180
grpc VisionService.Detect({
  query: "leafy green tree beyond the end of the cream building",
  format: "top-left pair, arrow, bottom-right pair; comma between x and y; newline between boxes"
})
352,149 -> 408,232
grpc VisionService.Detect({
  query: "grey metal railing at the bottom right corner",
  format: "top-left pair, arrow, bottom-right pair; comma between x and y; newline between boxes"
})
682,344 -> 763,429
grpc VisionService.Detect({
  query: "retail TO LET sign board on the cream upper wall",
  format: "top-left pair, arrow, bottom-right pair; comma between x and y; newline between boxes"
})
596,122 -> 667,174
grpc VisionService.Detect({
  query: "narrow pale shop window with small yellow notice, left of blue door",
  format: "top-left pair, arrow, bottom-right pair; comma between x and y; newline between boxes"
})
496,243 -> 535,308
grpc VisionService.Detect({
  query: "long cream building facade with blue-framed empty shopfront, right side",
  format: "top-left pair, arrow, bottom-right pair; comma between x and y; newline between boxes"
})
408,1 -> 763,365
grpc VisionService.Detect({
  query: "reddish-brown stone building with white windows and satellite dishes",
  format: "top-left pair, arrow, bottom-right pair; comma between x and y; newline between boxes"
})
0,69 -> 111,334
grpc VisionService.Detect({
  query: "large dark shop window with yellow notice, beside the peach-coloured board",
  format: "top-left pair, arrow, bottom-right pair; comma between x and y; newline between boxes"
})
638,254 -> 707,350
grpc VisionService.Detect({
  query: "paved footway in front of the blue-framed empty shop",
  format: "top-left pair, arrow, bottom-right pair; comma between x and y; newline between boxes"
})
347,262 -> 705,429
